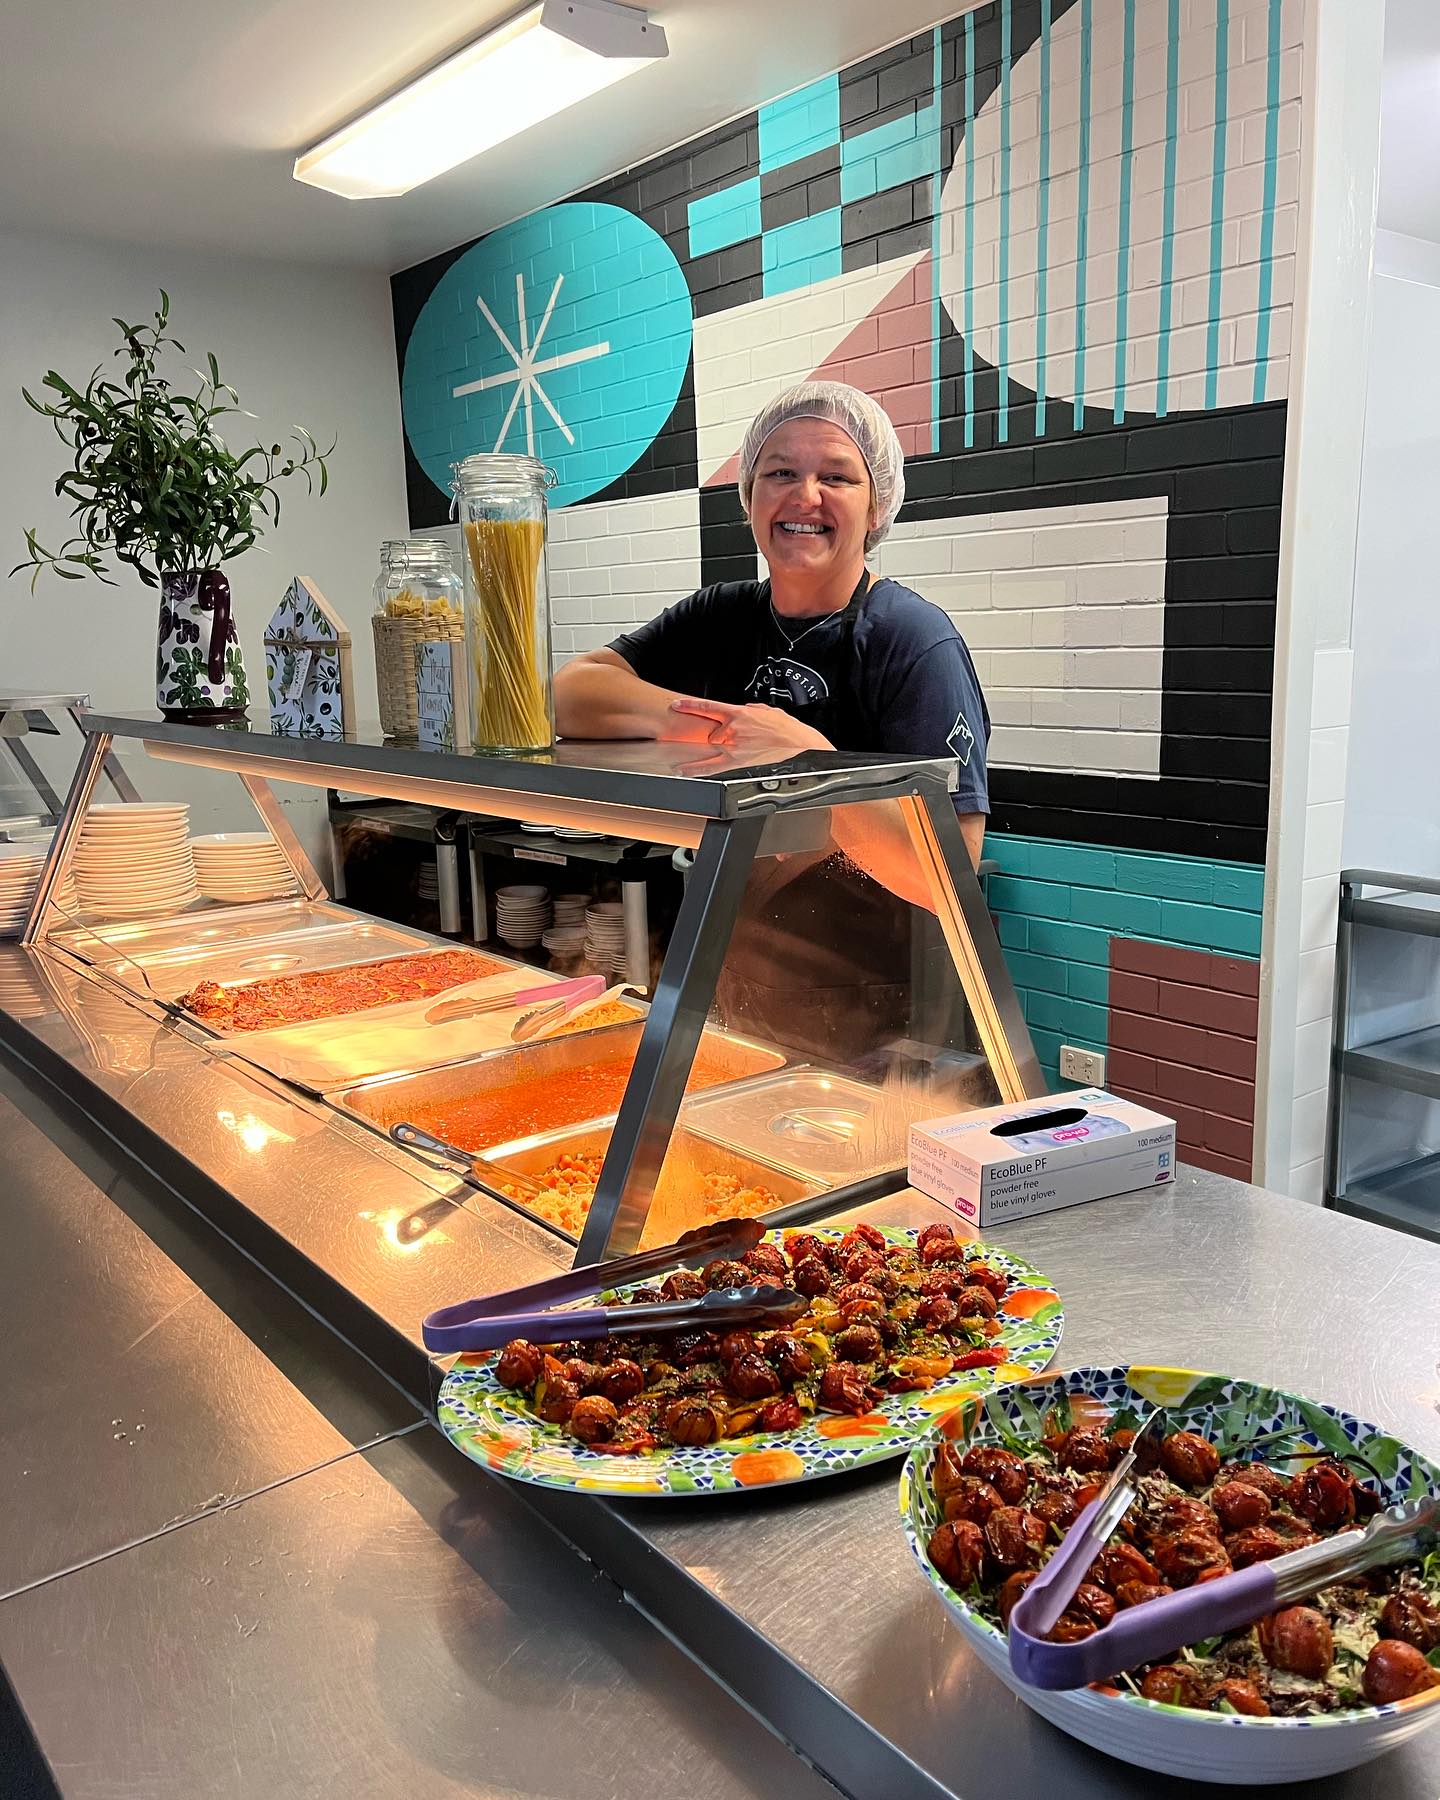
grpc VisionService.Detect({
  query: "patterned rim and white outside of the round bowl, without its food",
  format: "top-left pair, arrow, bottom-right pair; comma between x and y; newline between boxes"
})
900,1364 -> 1440,1787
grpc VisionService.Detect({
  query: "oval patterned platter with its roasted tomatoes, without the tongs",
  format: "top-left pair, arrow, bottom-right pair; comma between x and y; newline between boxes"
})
439,1224 -> 1064,1496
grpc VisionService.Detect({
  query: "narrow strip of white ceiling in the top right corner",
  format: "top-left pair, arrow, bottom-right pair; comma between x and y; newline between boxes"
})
1379,0 -> 1440,241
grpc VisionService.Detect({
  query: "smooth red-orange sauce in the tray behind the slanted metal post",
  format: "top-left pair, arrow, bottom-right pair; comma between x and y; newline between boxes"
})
365,1042 -> 742,1150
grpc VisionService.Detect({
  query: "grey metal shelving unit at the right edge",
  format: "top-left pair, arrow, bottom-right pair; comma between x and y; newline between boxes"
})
1325,869 -> 1440,1242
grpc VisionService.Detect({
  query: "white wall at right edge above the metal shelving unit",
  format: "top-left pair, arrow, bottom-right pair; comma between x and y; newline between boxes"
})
1345,239 -> 1440,875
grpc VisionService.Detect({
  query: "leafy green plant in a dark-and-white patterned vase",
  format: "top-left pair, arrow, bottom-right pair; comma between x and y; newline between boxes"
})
11,288 -> 335,720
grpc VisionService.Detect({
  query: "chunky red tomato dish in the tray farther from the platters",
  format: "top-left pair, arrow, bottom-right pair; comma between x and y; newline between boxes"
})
180,950 -> 508,1031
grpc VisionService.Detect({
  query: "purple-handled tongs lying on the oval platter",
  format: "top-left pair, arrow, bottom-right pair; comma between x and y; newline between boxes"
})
421,1219 -> 810,1355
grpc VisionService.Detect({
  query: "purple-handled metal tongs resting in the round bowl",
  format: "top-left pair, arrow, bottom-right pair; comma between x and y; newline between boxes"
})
1010,1496 -> 1440,1688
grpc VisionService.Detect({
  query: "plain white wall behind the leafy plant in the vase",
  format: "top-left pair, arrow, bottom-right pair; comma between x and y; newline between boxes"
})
0,232 -> 405,864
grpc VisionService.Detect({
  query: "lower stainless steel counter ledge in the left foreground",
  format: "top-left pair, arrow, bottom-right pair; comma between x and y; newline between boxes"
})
0,1071 -> 832,1800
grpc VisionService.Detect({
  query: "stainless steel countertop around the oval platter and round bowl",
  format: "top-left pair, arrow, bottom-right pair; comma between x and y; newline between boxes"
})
526,1168 -> 1440,1800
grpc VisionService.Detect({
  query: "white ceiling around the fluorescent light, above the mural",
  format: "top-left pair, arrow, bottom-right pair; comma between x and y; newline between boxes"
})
0,0 -> 965,270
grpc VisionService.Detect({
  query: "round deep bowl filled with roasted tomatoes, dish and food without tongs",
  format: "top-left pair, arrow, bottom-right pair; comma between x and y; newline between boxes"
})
900,1366 -> 1440,1786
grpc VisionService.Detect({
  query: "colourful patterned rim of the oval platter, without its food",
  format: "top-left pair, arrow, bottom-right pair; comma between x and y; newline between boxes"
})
439,1226 -> 1066,1498
